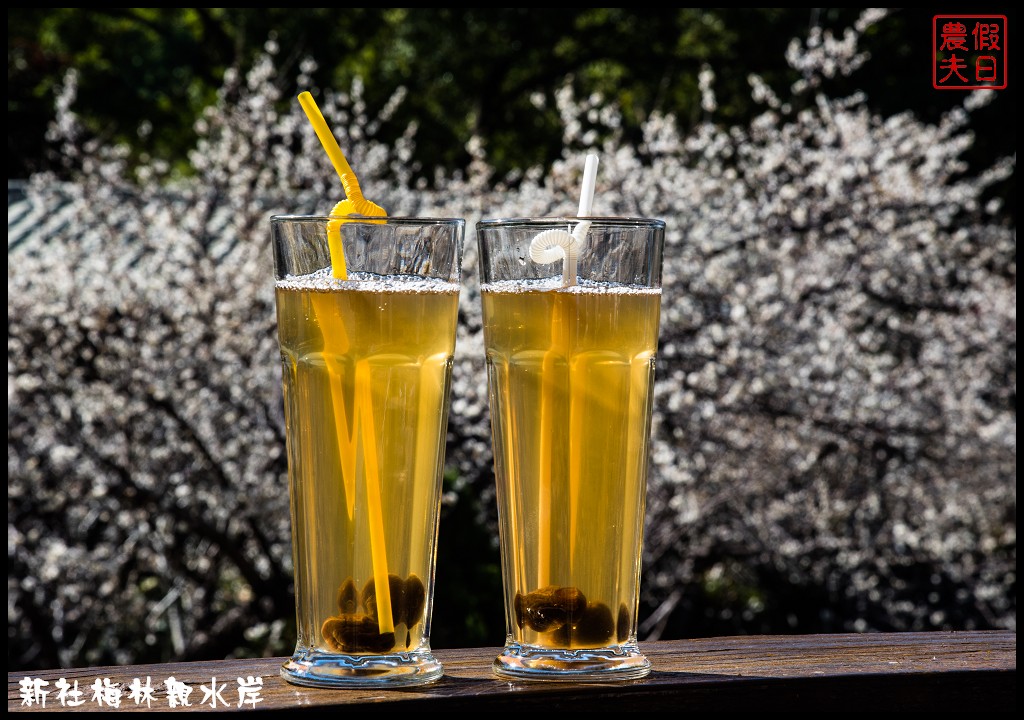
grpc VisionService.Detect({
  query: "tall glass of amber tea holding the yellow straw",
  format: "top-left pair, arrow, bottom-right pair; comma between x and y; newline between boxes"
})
270,216 -> 465,687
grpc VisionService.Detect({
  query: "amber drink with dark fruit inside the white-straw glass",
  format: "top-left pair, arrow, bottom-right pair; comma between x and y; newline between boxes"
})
480,281 -> 662,650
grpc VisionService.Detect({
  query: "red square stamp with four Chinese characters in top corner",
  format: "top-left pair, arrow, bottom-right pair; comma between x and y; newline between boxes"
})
932,15 -> 1007,90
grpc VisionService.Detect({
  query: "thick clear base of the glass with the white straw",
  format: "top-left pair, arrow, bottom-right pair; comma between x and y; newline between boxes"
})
494,642 -> 650,682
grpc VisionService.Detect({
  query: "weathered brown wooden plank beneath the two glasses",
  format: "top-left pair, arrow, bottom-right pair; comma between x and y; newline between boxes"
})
7,631 -> 1017,712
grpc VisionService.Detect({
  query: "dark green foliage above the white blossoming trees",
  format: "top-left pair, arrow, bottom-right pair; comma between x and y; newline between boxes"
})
7,8 -> 1016,202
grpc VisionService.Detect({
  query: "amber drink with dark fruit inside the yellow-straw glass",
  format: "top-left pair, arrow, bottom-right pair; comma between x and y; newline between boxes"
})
275,273 -> 459,657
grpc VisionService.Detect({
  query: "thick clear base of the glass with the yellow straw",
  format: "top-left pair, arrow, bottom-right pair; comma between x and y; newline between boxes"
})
281,651 -> 443,687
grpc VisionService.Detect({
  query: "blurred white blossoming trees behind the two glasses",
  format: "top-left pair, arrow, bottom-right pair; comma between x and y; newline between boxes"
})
7,10 -> 1017,670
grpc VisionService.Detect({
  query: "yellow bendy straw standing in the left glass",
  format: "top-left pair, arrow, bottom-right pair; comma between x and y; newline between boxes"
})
299,92 -> 394,635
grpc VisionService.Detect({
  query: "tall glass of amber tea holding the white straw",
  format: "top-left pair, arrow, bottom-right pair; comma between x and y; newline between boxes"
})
476,217 -> 665,680
